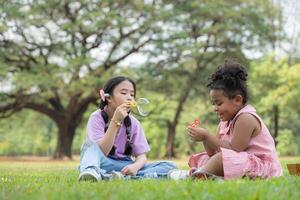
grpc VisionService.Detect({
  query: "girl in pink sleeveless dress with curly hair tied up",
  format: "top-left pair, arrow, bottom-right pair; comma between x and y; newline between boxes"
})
169,61 -> 282,179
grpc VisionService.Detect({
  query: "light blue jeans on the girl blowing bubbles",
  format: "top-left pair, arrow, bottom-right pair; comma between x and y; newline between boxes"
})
78,140 -> 177,178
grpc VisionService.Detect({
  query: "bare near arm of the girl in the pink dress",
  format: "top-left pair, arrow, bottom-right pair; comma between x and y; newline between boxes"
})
221,113 -> 260,152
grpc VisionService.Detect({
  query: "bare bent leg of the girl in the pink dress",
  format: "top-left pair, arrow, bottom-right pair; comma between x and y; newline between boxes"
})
202,152 -> 224,176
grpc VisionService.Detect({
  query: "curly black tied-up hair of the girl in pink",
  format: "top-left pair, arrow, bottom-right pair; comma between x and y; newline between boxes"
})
207,60 -> 249,104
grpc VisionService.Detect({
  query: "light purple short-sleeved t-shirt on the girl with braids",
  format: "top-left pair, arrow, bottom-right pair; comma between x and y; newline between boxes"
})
87,110 -> 150,158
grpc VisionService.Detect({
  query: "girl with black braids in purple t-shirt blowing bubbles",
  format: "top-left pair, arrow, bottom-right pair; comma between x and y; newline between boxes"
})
79,76 -> 176,181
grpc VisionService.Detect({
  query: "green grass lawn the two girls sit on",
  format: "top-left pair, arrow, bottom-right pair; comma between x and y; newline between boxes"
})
0,157 -> 300,200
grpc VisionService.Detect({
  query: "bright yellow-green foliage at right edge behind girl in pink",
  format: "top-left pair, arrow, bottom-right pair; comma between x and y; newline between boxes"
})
250,56 -> 300,109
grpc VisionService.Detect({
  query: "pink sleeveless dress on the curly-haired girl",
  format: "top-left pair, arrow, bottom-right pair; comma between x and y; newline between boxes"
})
189,105 -> 282,179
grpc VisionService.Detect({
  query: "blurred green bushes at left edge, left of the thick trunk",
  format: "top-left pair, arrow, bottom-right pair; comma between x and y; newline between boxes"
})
0,111 -> 56,156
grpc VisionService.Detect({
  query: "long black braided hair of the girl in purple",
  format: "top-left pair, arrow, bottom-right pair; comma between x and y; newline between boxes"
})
99,76 -> 136,155
